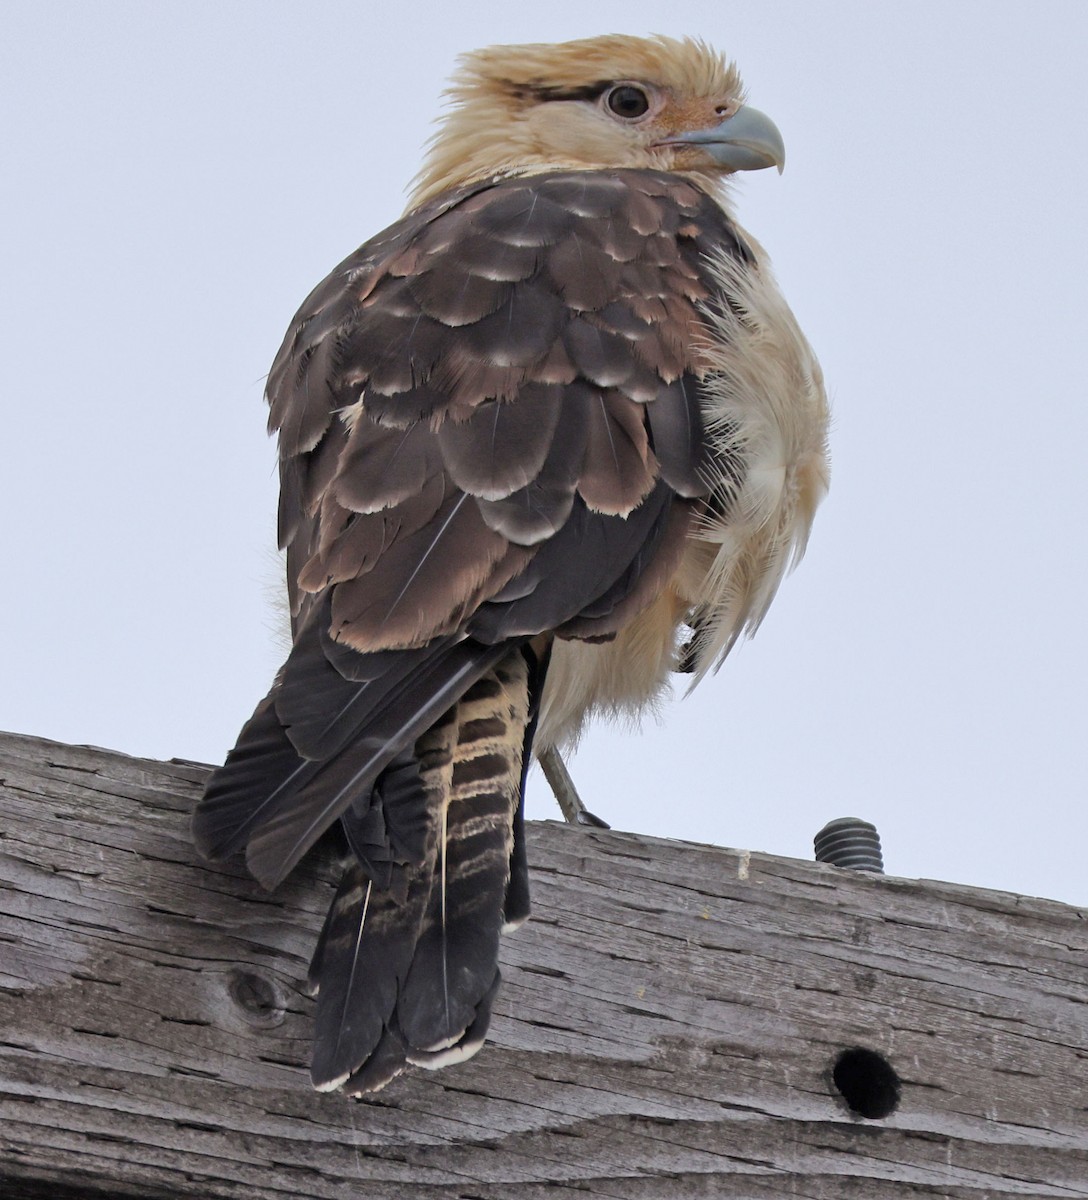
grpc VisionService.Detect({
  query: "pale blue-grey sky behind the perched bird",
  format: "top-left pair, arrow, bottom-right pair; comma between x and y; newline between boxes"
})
0,0 -> 1088,905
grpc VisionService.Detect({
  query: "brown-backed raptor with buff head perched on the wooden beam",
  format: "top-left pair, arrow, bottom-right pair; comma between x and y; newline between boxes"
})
193,35 -> 829,1096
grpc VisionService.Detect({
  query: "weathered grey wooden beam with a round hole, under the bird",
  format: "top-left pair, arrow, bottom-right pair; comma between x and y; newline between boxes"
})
0,736 -> 1088,1200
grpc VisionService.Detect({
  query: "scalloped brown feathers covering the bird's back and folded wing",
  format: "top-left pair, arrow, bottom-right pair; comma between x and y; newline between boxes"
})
268,170 -> 745,647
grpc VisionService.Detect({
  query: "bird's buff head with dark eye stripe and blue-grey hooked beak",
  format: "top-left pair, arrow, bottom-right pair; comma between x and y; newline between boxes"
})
411,35 -> 786,206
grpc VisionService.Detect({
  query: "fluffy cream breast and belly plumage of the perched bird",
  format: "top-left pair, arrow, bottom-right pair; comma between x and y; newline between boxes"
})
536,195 -> 829,750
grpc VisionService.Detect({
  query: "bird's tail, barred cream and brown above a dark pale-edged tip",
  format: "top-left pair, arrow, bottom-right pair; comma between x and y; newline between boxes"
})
311,648 -> 542,1093
